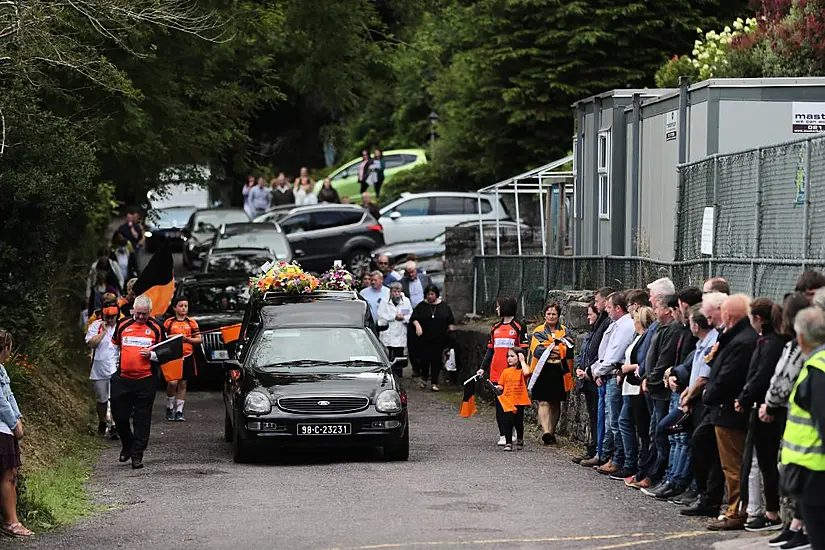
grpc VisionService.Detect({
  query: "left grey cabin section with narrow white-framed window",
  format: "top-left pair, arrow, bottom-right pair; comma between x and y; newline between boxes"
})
573,90 -> 672,255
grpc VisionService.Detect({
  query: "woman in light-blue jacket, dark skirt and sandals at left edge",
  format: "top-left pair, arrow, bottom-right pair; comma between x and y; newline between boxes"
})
0,329 -> 34,537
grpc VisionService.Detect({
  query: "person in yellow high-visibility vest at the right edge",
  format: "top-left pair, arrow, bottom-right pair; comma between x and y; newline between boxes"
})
782,307 -> 825,549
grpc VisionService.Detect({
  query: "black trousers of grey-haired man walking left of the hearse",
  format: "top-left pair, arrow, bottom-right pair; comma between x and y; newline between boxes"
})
111,374 -> 157,458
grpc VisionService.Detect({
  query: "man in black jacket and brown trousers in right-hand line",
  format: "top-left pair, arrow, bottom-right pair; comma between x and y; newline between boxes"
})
702,295 -> 759,531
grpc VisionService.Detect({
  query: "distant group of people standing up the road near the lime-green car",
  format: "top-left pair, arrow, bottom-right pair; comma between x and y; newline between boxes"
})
243,149 -> 385,219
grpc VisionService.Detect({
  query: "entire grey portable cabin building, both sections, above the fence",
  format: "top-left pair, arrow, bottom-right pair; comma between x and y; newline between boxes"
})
573,77 -> 825,261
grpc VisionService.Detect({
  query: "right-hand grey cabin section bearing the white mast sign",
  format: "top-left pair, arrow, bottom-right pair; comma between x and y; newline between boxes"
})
625,78 -> 825,261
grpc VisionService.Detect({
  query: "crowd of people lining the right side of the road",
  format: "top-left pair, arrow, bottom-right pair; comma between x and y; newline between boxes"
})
470,271 -> 825,549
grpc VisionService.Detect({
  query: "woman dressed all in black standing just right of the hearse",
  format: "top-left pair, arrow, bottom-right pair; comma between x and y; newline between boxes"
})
410,285 -> 455,391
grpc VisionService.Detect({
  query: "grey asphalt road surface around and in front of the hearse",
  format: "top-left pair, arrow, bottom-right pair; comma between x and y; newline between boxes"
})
20,382 -> 764,550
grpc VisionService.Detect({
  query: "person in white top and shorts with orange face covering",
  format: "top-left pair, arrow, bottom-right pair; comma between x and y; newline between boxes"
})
86,303 -> 120,435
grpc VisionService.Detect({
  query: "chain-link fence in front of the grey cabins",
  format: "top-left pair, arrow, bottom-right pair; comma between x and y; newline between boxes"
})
474,136 -> 825,315
